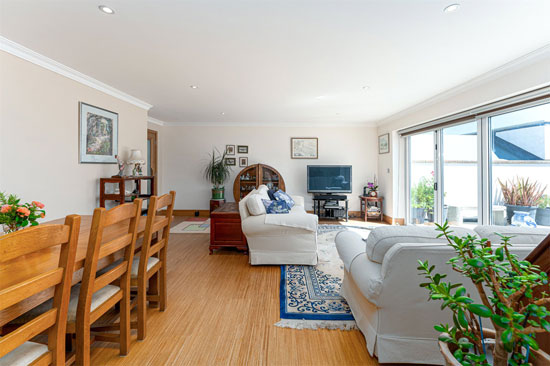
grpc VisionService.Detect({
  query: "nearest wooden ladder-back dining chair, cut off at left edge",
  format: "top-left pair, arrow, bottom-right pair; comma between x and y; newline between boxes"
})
0,215 -> 80,366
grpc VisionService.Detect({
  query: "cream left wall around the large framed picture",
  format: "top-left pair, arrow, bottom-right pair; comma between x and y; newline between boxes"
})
0,51 -> 147,220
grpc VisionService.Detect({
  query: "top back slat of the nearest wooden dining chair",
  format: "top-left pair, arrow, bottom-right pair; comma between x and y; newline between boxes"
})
0,225 -> 69,263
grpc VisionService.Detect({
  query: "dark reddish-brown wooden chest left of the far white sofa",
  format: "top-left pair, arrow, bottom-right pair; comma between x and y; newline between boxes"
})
209,202 -> 248,254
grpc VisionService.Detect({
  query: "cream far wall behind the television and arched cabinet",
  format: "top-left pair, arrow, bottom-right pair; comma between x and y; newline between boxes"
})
157,124 -> 377,211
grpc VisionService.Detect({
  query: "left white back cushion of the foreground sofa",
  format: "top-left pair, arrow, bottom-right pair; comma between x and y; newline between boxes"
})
366,225 -> 476,263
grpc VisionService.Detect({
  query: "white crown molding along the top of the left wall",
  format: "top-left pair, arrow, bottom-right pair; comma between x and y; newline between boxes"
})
0,36 -> 153,110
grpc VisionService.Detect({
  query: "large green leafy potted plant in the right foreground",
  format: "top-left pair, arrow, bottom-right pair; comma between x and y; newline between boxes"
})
418,222 -> 550,366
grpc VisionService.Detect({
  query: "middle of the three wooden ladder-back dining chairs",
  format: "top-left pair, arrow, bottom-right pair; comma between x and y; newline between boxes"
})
67,199 -> 142,366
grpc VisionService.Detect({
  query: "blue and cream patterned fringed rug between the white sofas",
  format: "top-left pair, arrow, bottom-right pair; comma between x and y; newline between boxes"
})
275,225 -> 370,330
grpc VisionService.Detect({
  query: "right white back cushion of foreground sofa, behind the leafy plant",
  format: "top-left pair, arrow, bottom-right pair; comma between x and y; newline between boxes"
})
474,225 -> 550,244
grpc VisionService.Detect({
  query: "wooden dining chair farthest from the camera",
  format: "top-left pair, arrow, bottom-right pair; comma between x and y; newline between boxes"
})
131,191 -> 176,340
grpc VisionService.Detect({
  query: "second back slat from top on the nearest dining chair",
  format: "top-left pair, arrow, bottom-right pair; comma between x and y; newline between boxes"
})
0,268 -> 63,310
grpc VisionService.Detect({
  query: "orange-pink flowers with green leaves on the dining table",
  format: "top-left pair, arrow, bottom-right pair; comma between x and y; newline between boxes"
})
0,192 -> 46,233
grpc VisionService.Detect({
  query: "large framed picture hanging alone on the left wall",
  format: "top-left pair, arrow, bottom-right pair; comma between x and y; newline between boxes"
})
79,102 -> 118,164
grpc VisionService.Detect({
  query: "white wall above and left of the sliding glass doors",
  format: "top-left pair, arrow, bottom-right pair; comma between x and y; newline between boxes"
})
378,52 -> 550,218
